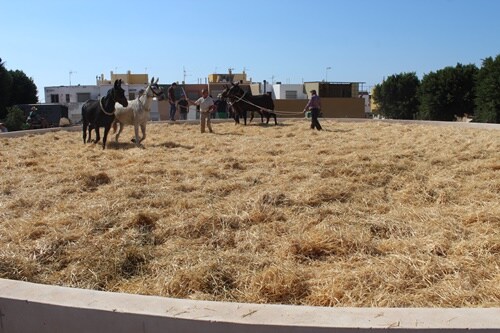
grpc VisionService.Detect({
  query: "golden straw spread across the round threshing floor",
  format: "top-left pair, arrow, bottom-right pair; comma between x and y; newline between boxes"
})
0,119 -> 500,307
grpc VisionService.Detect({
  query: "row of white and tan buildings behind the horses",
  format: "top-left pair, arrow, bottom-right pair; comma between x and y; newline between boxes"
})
44,69 -> 366,123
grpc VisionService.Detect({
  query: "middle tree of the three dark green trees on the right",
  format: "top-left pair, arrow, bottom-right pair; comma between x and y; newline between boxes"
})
418,64 -> 478,121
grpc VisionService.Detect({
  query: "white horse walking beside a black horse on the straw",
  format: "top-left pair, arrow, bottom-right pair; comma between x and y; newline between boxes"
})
113,77 -> 163,147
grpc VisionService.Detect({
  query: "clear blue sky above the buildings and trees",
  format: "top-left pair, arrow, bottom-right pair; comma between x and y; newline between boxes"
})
0,0 -> 500,102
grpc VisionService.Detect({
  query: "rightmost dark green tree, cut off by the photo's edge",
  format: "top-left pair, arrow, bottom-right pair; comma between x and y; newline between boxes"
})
474,55 -> 500,123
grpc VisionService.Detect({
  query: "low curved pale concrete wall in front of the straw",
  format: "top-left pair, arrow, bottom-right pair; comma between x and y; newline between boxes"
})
0,279 -> 500,333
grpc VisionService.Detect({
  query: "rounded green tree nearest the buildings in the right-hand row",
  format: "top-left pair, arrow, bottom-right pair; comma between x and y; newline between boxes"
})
373,72 -> 420,119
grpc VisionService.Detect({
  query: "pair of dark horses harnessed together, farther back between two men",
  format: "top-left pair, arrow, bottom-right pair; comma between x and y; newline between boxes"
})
221,83 -> 278,125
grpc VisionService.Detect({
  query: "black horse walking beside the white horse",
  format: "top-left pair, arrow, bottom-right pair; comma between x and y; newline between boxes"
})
82,80 -> 128,149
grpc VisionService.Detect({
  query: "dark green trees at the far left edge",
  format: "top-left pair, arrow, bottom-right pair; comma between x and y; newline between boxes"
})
0,59 -> 38,130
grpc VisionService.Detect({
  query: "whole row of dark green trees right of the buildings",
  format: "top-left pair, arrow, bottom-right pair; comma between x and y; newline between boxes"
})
373,55 -> 500,123
